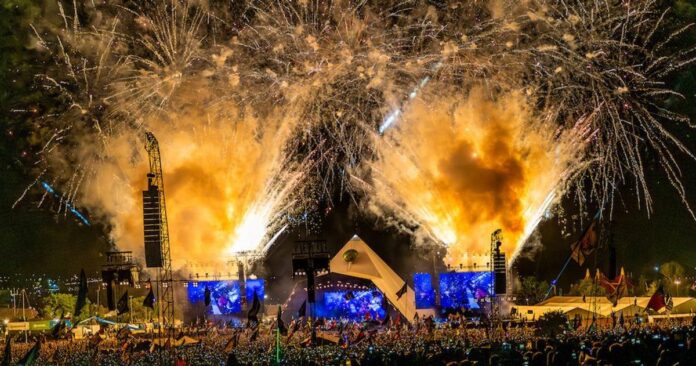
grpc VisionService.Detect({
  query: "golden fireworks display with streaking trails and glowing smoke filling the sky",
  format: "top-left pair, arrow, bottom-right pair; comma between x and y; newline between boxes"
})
21,0 -> 694,263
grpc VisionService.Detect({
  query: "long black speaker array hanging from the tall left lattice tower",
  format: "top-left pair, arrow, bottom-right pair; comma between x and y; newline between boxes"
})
143,174 -> 162,267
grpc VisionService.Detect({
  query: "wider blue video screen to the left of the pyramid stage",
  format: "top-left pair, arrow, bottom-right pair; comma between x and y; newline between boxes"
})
188,281 -> 242,315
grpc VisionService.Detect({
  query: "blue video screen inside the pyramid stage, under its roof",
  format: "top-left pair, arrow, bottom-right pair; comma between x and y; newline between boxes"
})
317,291 -> 386,319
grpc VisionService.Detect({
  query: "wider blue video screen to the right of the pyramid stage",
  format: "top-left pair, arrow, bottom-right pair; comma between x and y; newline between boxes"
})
440,272 -> 493,309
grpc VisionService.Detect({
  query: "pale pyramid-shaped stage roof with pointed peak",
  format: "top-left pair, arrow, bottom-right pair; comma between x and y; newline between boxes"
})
329,235 -> 416,321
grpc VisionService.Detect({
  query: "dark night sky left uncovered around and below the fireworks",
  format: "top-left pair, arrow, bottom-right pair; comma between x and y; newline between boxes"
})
0,0 -> 696,292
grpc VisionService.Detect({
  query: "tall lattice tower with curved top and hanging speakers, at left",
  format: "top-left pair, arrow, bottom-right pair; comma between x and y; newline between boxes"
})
143,132 -> 174,344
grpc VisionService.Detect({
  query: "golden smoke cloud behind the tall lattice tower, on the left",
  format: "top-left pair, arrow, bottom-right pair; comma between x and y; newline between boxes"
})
81,79 -> 302,268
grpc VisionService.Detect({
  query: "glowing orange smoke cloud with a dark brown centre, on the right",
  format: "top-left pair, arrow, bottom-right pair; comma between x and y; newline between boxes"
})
358,88 -> 582,265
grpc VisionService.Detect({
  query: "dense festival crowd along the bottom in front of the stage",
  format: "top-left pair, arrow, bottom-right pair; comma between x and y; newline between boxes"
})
2,318 -> 696,366
